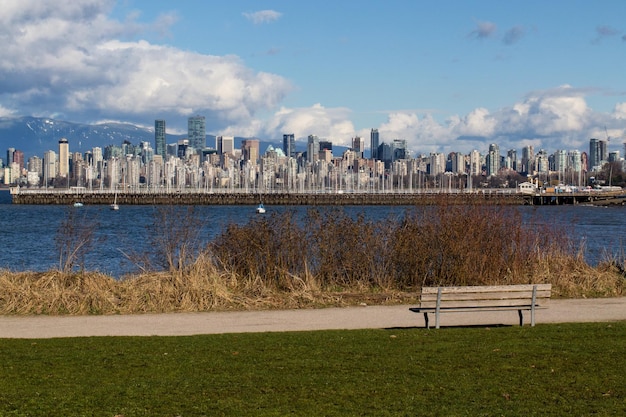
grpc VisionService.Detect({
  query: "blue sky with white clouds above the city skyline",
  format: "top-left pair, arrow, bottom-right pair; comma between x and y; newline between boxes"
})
0,0 -> 626,156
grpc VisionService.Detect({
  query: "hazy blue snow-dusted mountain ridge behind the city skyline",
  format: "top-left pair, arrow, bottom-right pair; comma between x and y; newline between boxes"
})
0,117 -> 346,159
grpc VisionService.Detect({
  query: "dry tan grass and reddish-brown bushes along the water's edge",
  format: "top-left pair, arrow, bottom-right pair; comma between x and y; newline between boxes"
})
0,203 -> 626,315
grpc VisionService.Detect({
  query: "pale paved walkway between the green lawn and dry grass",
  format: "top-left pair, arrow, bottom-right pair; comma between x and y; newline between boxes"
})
0,297 -> 626,339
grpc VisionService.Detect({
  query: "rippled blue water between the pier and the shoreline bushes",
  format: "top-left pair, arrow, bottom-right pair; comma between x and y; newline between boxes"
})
0,190 -> 626,277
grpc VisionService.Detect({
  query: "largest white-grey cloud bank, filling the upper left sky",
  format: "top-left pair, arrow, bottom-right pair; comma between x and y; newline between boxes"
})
0,0 -> 292,128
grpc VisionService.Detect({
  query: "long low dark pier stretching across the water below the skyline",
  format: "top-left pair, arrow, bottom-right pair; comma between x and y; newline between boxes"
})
11,187 -> 626,206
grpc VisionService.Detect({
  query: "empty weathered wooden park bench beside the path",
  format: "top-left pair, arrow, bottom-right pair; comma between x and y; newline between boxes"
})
409,284 -> 552,329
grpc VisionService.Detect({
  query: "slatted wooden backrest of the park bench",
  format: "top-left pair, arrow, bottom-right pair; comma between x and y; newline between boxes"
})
420,284 -> 552,308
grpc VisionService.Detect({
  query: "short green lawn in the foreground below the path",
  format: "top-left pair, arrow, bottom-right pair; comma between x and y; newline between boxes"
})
0,322 -> 626,417
